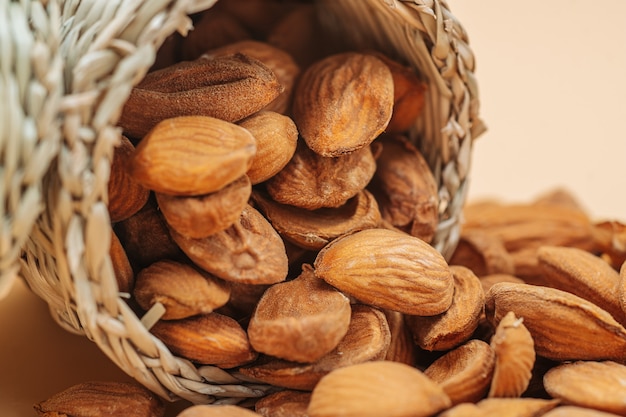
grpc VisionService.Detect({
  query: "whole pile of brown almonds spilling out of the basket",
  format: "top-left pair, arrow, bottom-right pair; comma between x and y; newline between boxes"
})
36,0 -> 626,417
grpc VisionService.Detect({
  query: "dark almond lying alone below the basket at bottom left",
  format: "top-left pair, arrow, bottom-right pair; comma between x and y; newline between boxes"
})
34,381 -> 165,417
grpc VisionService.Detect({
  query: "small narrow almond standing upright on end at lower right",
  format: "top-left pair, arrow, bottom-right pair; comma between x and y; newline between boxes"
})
488,311 -> 535,397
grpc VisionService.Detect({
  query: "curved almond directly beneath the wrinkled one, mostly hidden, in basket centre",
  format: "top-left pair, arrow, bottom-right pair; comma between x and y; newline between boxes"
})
252,190 -> 381,251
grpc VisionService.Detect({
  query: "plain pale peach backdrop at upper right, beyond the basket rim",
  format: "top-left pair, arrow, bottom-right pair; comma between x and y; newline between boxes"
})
448,0 -> 626,219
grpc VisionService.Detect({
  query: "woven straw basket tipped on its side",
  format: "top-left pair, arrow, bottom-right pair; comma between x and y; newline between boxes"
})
0,0 -> 483,403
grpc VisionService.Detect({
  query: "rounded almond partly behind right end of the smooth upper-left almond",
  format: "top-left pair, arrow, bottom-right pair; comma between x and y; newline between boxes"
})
239,111 -> 298,185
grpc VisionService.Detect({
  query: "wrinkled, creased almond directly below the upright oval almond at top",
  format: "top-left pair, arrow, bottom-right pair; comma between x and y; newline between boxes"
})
265,141 -> 376,210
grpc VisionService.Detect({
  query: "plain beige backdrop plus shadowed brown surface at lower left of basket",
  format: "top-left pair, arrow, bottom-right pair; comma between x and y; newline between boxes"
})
0,0 -> 626,417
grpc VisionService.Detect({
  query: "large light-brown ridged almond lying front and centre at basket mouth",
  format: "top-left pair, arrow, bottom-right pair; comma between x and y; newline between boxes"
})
314,229 -> 454,316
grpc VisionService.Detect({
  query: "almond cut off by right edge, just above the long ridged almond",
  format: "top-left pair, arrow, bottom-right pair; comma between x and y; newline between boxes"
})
537,246 -> 626,324
